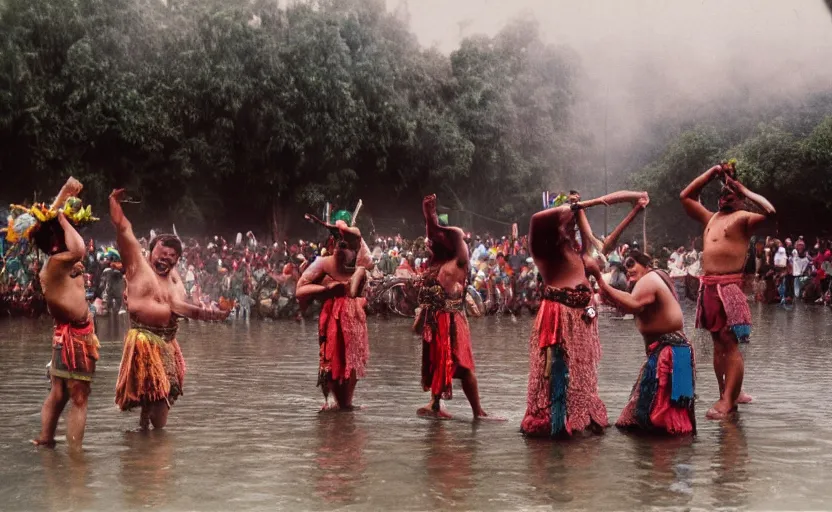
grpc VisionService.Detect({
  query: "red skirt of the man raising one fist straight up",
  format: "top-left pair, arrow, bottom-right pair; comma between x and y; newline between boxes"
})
422,308 -> 474,400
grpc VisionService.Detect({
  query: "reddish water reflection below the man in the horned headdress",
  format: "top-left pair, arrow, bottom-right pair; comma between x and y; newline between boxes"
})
315,414 -> 367,504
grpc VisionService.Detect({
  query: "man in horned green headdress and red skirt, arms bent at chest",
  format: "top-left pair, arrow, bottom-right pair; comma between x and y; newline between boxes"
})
295,212 -> 372,411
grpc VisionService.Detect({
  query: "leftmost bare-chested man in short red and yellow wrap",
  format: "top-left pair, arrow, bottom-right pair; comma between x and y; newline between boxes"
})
32,178 -> 99,448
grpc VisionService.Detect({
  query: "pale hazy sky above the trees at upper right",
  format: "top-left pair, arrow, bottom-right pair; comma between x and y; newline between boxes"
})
386,0 -> 832,174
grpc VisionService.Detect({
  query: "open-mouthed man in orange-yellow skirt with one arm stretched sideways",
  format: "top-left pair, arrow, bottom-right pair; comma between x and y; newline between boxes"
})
110,190 -> 229,429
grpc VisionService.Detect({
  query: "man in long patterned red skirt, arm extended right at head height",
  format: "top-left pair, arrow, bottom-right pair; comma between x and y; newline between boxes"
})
521,191 -> 646,437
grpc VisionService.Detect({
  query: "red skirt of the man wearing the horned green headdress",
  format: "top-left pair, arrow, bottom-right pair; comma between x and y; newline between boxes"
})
318,297 -> 370,382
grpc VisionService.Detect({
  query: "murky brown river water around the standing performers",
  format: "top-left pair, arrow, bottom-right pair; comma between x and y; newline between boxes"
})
0,307 -> 832,511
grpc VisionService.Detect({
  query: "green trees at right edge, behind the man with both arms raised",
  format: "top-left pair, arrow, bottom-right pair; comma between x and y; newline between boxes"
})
631,116 -> 832,243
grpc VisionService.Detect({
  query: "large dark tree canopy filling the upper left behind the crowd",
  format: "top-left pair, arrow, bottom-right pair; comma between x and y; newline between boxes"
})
0,0 -> 574,238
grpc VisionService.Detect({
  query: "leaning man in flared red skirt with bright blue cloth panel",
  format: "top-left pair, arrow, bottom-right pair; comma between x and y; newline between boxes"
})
586,200 -> 696,435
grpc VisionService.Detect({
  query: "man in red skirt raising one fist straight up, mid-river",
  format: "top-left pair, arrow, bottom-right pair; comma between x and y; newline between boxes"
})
414,195 -> 488,419
